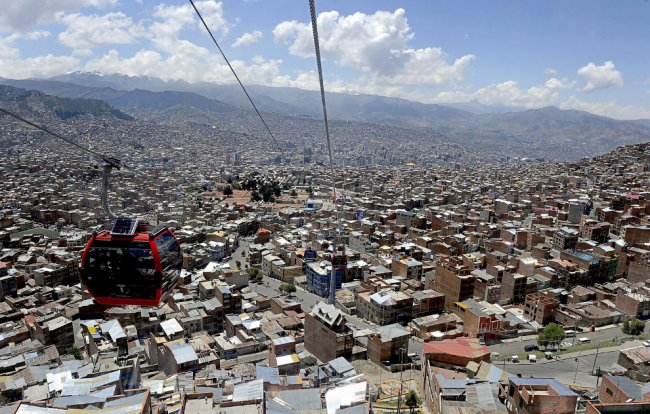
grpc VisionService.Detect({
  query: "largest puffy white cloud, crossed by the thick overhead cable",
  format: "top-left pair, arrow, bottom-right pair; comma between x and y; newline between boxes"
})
273,9 -> 475,88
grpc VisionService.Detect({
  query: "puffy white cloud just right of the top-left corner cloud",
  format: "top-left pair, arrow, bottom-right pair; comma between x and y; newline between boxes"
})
59,12 -> 145,55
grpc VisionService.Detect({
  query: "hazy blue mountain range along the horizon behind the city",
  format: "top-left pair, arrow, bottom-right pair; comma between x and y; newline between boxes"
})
0,73 -> 650,160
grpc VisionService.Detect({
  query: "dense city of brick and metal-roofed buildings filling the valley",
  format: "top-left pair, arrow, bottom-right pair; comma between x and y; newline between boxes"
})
0,77 -> 650,414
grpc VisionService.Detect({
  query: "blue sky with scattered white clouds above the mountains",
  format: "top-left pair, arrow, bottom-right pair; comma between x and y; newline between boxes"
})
0,0 -> 650,119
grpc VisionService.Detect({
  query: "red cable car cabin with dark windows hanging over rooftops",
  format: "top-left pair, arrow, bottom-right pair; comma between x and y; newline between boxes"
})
81,218 -> 183,306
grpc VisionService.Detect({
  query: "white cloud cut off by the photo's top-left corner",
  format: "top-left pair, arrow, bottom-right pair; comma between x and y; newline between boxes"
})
0,0 -> 117,32
